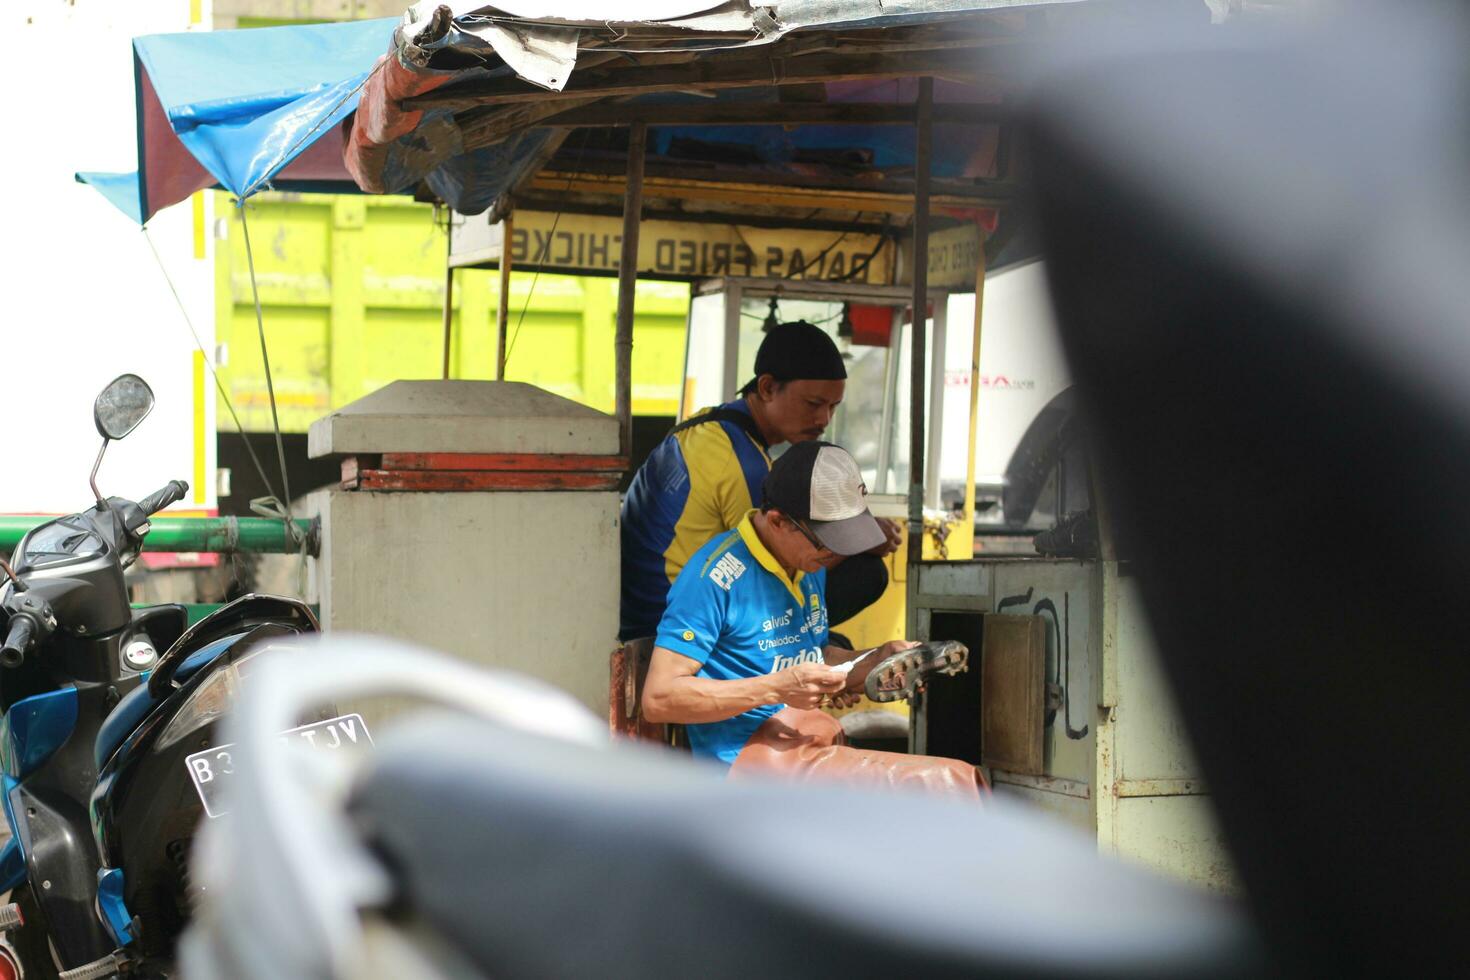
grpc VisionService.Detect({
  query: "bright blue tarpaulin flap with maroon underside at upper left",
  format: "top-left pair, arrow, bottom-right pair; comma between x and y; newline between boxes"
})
76,18 -> 398,223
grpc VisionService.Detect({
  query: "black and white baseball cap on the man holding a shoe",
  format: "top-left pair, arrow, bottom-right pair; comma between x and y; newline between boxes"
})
763,441 -> 888,555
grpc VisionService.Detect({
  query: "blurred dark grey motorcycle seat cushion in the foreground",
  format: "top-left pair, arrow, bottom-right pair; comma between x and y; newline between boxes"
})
350,716 -> 1266,979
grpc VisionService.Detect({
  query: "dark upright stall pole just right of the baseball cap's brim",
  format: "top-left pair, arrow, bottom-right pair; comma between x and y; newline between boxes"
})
908,78 -> 941,576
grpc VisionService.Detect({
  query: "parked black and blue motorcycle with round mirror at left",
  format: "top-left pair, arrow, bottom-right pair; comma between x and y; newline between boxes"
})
0,375 -> 319,980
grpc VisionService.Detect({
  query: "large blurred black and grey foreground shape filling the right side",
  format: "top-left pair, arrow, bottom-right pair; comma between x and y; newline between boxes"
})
1032,3 -> 1470,976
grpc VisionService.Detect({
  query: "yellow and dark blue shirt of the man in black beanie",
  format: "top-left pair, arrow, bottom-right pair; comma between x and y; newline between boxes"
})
619,398 -> 770,641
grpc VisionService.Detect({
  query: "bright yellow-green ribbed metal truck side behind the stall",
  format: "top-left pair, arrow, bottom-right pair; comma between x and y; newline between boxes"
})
216,192 -> 689,432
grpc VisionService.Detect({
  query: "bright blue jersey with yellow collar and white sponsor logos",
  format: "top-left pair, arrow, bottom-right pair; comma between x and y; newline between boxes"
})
654,511 -> 828,765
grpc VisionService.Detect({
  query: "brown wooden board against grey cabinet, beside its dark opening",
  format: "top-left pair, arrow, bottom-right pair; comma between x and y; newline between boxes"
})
980,614 -> 1047,776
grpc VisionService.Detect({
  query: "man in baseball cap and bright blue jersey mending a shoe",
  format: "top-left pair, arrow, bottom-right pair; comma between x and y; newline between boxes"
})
642,441 -> 983,799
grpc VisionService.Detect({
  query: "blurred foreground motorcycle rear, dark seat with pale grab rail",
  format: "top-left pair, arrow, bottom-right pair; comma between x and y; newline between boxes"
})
181,635 -> 1261,980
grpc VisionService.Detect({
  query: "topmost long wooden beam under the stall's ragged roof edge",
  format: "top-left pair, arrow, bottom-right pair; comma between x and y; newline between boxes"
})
403,48 -> 994,112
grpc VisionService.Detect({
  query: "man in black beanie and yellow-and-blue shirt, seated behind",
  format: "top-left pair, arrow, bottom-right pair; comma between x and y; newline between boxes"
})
619,322 -> 900,641
